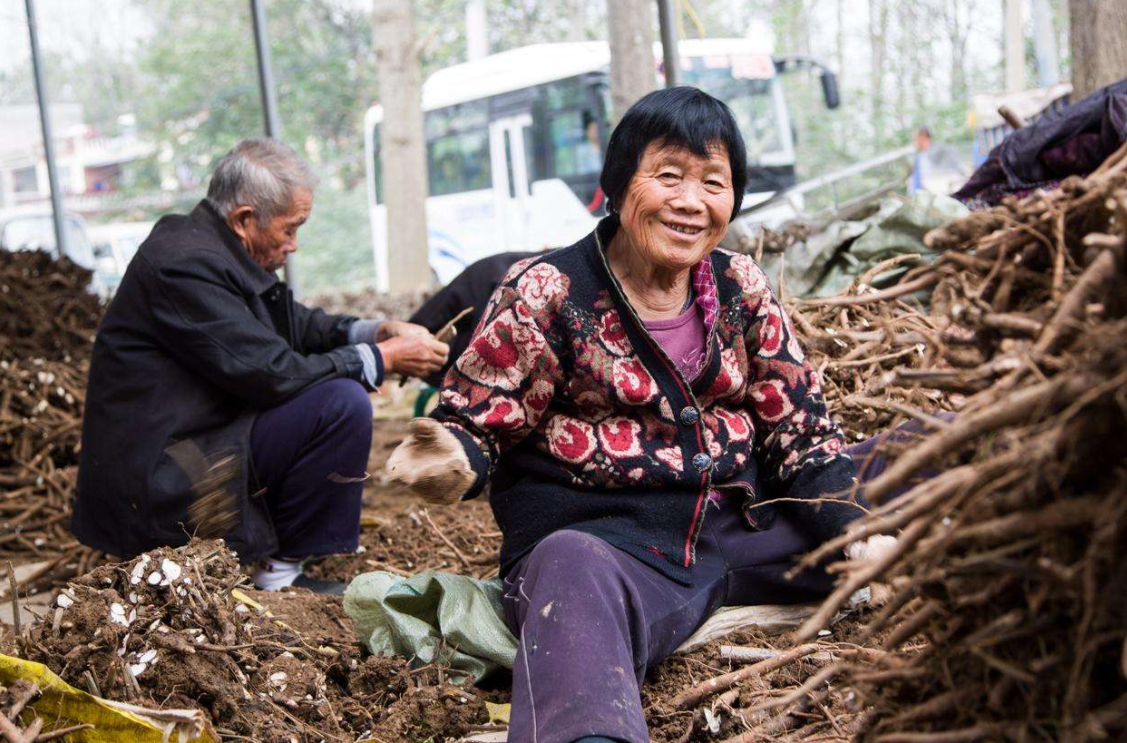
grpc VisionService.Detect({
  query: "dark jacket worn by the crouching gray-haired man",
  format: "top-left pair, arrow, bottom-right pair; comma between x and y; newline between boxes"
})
71,202 -> 363,560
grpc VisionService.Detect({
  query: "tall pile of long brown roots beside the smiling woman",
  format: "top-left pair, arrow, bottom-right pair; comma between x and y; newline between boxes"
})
658,140 -> 1127,743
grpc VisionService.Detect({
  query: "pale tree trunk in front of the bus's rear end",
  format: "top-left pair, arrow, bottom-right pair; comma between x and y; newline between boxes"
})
372,0 -> 432,292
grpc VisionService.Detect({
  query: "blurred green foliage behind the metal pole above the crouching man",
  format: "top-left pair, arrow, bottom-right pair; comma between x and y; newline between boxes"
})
137,0 -> 375,185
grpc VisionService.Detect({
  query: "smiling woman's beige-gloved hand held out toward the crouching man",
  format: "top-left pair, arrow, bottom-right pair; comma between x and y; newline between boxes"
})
388,418 -> 476,505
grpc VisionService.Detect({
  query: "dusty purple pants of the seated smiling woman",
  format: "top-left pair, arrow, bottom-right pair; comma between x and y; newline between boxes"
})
504,424 -> 933,743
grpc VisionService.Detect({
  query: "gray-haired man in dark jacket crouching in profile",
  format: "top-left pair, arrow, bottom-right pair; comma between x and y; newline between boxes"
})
71,140 -> 447,592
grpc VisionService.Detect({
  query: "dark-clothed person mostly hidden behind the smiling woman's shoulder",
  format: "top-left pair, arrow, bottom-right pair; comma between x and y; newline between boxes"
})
408,253 -> 540,387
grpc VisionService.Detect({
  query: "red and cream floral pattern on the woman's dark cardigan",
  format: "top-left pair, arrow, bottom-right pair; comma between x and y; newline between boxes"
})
438,244 -> 842,500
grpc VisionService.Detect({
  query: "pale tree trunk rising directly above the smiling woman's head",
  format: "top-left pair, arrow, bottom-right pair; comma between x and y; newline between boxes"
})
606,0 -> 657,122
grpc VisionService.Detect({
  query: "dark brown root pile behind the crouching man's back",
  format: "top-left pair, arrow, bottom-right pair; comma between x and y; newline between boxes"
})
0,250 -> 101,593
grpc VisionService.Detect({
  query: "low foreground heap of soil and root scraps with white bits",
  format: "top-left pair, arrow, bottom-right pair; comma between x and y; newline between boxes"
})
12,540 -> 498,743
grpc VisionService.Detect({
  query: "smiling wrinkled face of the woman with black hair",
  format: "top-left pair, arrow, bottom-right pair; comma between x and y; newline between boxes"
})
620,142 -> 735,271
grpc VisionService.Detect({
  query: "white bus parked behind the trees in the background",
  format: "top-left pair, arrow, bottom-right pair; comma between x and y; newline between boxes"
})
364,38 -> 836,291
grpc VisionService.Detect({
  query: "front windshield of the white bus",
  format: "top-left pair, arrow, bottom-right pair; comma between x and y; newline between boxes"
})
682,56 -> 788,165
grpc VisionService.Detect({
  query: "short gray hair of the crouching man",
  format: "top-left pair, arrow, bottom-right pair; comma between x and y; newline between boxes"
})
207,139 -> 317,221
